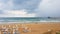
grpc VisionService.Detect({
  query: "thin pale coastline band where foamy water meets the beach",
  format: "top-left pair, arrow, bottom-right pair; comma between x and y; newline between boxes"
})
0,21 -> 60,24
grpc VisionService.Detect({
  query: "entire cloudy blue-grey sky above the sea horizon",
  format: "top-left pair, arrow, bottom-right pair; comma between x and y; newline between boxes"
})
0,0 -> 60,17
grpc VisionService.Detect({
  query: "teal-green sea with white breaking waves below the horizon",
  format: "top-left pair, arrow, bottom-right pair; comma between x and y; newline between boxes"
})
0,17 -> 60,24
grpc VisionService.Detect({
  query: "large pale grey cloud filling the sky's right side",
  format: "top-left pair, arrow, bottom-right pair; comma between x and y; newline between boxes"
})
36,0 -> 60,17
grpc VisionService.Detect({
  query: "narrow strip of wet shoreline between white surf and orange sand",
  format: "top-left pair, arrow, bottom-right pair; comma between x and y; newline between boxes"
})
0,22 -> 60,24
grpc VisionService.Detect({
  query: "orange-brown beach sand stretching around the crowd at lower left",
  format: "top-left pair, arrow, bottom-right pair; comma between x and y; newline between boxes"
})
0,22 -> 60,34
